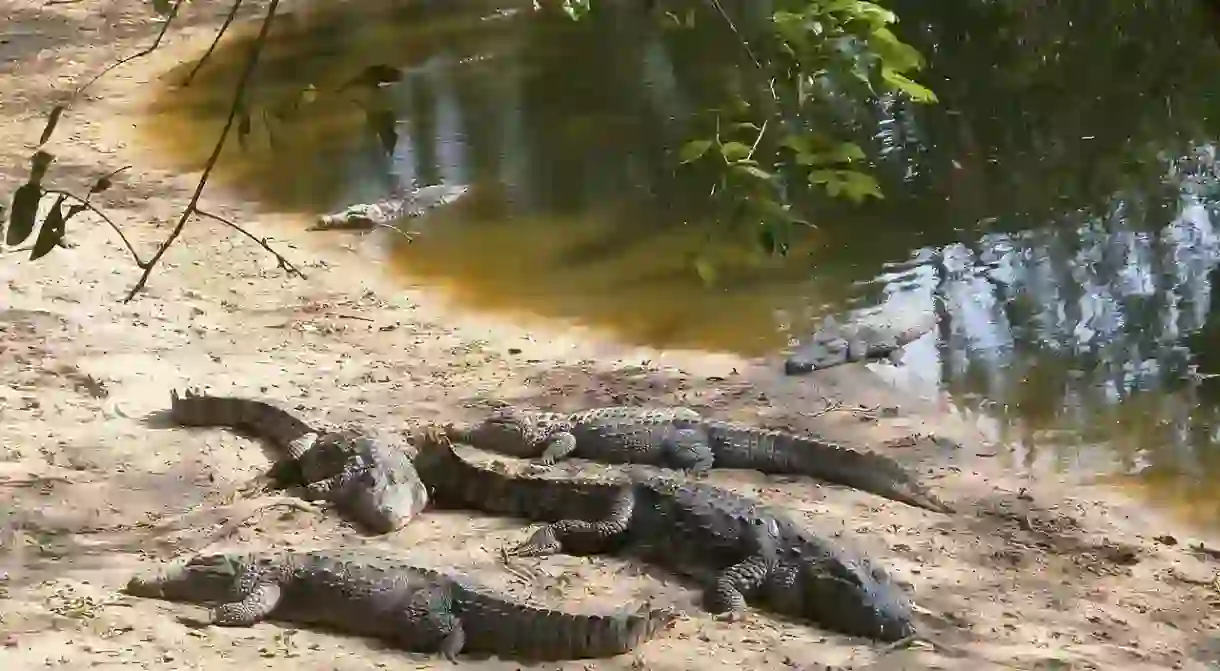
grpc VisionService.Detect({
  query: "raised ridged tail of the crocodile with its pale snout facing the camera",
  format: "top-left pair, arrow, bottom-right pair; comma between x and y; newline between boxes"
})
170,389 -> 314,456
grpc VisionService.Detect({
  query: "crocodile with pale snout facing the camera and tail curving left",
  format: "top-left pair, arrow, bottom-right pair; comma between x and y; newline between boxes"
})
170,389 -> 428,533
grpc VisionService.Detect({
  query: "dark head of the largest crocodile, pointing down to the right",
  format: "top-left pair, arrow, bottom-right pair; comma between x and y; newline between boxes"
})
766,553 -> 915,642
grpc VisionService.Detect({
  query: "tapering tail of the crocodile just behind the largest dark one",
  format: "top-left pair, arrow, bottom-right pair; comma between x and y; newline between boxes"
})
704,421 -> 952,512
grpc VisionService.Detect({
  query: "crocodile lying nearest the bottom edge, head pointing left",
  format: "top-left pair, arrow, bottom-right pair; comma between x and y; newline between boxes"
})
123,549 -> 676,661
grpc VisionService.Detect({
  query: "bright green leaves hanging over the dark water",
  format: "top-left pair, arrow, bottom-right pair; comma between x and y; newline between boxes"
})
669,0 -> 937,254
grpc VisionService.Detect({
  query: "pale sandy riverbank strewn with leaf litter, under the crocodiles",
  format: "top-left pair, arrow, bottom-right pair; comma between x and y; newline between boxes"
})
0,0 -> 1220,670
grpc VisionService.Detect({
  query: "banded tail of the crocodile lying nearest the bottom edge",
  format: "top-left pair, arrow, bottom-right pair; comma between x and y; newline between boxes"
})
458,590 -> 677,661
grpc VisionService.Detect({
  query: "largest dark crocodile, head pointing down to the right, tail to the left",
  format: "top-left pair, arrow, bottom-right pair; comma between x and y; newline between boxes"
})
416,427 -> 914,641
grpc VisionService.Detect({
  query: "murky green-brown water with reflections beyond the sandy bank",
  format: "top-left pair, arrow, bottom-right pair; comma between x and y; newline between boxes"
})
140,0 -> 1220,531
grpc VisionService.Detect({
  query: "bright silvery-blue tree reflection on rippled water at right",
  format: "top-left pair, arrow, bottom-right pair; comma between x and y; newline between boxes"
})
893,146 -> 1220,471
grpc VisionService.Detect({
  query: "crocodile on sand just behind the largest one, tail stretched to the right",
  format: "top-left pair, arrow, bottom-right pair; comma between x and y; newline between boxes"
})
445,405 -> 953,512
